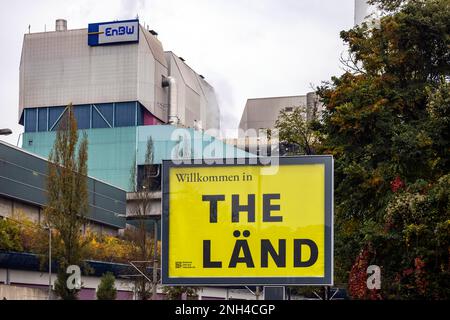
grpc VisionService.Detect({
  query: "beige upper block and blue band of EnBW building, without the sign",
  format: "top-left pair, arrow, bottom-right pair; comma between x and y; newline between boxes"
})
19,20 -> 220,132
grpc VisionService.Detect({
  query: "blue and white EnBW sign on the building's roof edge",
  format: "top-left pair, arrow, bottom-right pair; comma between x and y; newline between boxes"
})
88,20 -> 139,46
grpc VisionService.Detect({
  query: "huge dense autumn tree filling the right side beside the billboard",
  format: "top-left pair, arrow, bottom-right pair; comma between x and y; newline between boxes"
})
318,0 -> 450,299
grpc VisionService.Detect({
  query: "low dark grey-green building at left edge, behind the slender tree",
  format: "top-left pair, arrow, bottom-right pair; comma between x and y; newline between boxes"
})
0,141 -> 126,235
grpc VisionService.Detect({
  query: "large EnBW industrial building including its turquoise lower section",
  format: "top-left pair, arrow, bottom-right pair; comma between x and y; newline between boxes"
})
19,20 -> 245,195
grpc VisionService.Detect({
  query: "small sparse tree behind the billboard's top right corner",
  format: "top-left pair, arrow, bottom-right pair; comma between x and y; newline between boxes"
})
275,106 -> 319,155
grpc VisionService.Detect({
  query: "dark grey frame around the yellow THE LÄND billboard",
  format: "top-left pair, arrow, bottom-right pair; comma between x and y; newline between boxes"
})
161,155 -> 334,286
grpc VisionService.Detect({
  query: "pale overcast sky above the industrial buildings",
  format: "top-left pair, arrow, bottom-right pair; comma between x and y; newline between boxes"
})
0,0 -> 354,144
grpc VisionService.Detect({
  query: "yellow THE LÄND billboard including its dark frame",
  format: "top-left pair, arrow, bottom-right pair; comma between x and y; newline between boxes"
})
162,156 -> 333,285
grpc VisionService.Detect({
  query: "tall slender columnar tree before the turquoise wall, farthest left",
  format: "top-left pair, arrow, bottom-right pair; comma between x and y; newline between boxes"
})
44,104 -> 88,299
